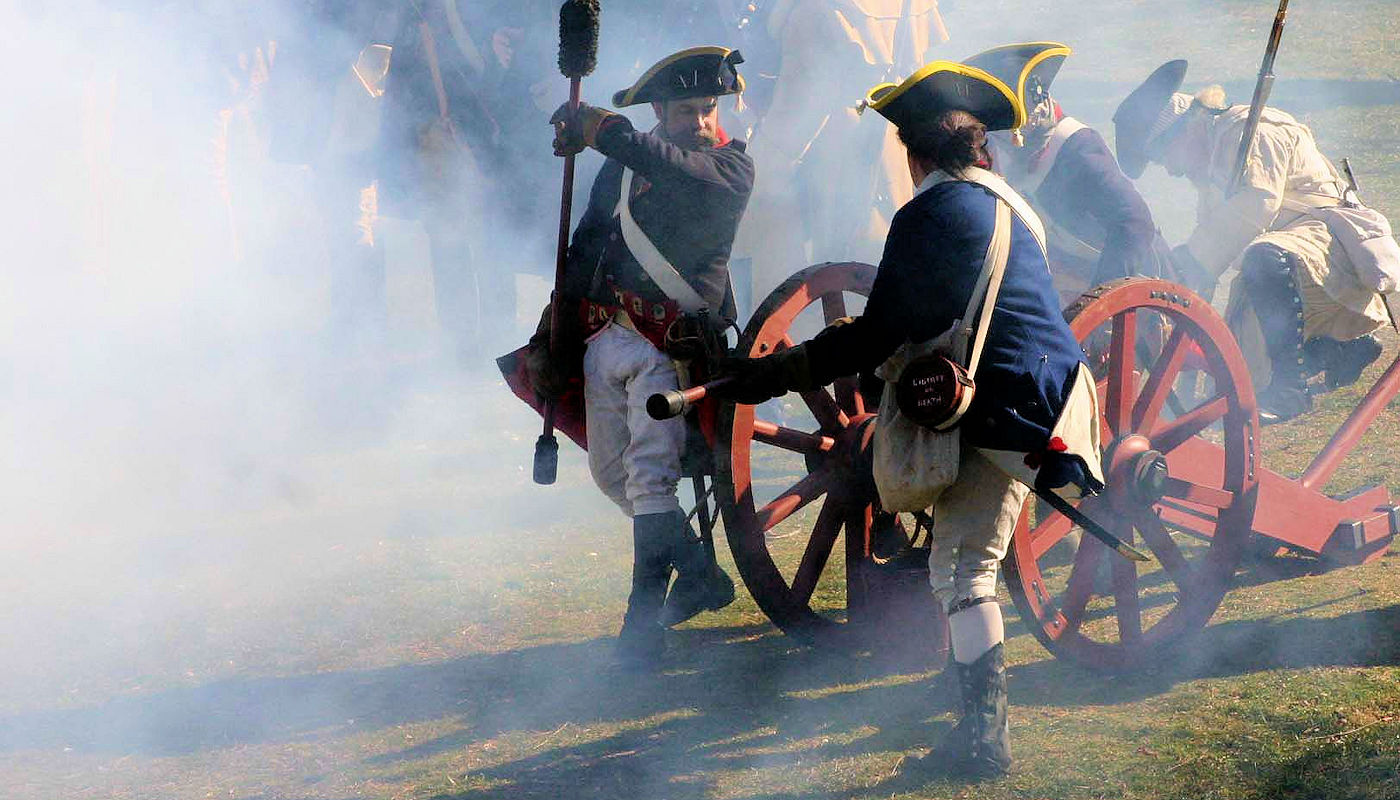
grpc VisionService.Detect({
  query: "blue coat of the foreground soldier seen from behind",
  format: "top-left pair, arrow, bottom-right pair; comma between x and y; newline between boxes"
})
806,181 -> 1084,453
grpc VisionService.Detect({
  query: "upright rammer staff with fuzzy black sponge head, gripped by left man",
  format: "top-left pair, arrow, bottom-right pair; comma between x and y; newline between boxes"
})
535,0 -> 601,486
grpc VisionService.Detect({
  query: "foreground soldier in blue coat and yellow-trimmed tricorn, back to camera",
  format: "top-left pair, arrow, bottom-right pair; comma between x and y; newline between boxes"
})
720,62 -> 1102,778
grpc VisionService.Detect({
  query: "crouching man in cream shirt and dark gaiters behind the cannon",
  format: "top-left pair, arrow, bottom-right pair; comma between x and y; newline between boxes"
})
1113,60 -> 1400,425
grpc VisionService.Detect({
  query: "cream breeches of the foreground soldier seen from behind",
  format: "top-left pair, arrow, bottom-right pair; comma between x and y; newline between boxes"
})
928,446 -> 1030,608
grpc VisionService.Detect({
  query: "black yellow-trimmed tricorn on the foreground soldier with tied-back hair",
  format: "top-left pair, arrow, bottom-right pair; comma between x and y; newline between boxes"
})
860,62 -> 1026,130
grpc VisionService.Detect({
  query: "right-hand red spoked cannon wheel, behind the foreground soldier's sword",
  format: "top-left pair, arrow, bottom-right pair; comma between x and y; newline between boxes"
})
1005,279 -> 1259,670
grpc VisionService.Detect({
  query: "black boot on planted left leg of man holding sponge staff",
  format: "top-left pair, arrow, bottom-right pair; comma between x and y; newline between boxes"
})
617,514 -> 675,668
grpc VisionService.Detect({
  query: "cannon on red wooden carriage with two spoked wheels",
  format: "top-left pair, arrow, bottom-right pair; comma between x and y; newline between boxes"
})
506,262 -> 1400,671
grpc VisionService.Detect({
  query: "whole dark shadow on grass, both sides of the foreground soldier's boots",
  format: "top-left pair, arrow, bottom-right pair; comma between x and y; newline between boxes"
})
0,608 -> 1400,800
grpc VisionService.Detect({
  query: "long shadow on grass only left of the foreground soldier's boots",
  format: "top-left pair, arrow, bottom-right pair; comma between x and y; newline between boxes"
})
0,625 -> 948,797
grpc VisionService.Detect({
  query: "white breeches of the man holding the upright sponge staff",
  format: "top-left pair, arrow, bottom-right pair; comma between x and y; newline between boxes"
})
584,324 -> 686,517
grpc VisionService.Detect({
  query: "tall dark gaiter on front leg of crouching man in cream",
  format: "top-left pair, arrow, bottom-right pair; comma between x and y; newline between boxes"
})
1240,245 -> 1312,425
